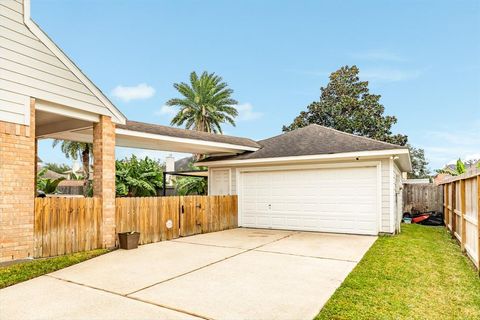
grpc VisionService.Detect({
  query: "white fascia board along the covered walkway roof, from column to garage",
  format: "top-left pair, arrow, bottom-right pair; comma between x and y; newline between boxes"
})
115,128 -> 258,151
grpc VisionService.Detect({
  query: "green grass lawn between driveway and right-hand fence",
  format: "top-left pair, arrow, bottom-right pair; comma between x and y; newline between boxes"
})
316,225 -> 480,320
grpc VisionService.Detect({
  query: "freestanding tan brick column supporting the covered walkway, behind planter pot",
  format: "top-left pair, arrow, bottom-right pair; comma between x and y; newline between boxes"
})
93,116 -> 116,248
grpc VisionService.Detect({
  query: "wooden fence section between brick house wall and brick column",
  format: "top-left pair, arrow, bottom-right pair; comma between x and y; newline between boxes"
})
34,197 -> 102,258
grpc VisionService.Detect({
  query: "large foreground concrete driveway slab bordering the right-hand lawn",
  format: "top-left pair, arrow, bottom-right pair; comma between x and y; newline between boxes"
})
132,251 -> 356,319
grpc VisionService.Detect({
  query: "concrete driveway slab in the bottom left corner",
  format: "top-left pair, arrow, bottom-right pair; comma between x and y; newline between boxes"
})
0,276 -> 198,320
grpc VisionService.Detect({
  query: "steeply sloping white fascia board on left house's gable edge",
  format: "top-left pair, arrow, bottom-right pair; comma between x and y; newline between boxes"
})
23,0 -> 127,124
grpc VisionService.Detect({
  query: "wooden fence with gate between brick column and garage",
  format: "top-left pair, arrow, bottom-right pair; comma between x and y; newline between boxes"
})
115,196 -> 238,244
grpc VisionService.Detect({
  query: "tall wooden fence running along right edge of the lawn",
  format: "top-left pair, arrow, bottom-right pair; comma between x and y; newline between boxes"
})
441,168 -> 480,271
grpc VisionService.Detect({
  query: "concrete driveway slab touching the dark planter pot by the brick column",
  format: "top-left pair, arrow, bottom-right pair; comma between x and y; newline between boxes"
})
51,241 -> 243,294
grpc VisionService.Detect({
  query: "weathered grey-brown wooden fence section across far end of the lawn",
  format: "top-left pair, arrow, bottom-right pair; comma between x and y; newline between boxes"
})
403,183 -> 443,212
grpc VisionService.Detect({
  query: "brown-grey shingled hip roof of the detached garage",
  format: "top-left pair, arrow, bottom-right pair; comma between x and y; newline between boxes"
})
199,124 -> 407,163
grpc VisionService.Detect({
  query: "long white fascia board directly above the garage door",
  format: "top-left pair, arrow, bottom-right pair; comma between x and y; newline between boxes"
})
195,149 -> 409,167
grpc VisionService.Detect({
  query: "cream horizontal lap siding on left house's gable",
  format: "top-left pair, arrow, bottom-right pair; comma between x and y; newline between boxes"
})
0,0 -> 111,124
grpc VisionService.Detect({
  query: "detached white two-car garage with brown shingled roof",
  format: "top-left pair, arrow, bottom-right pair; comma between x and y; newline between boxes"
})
199,125 -> 411,235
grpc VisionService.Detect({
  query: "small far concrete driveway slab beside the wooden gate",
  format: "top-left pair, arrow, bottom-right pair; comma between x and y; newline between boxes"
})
174,228 -> 296,249
